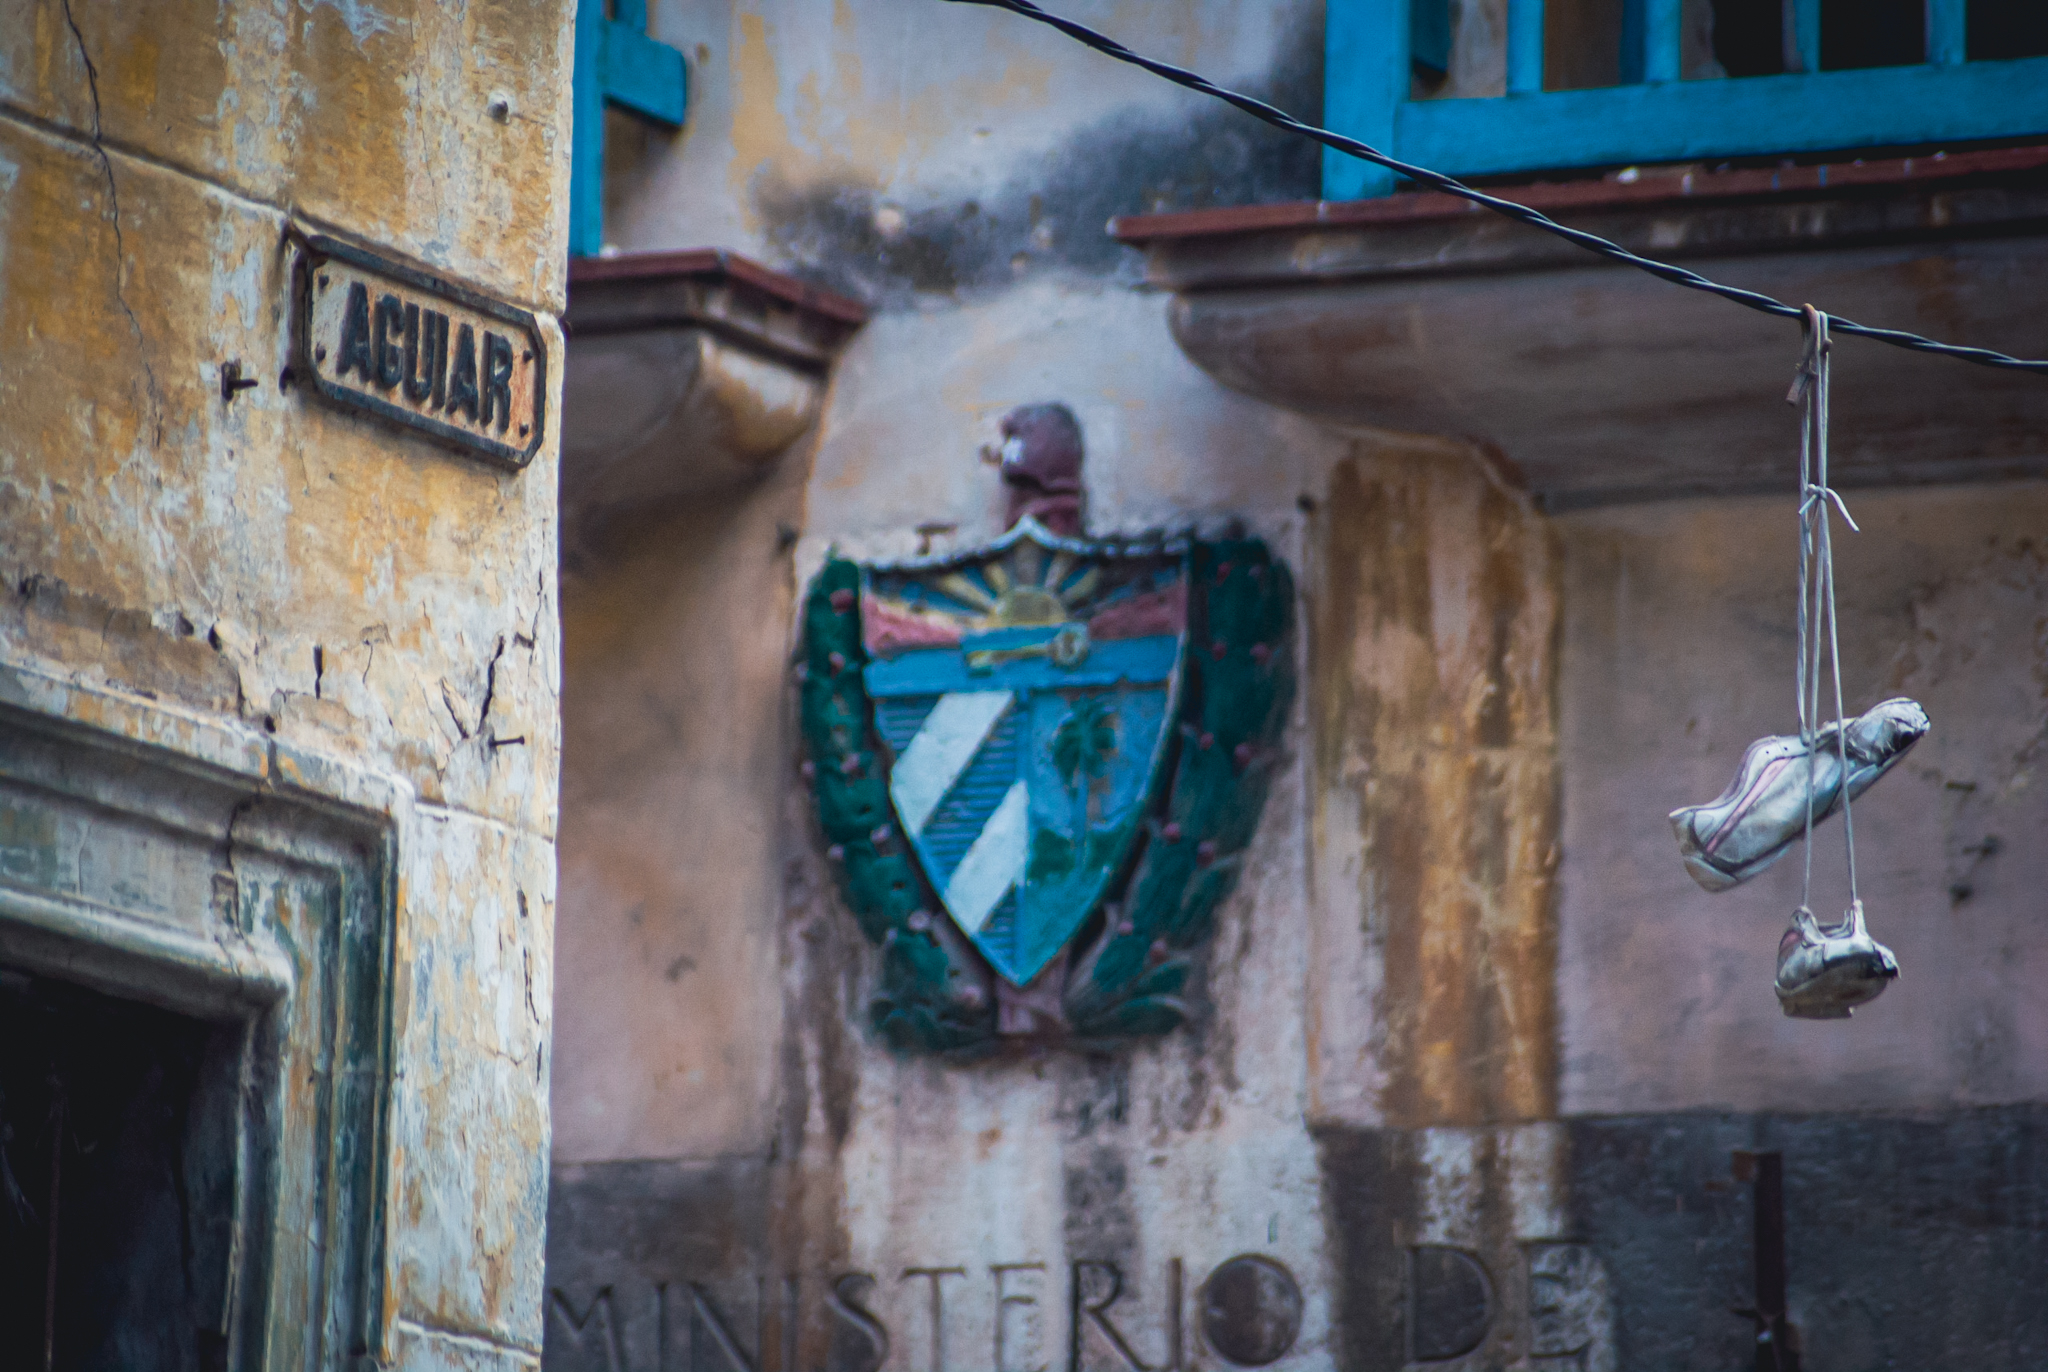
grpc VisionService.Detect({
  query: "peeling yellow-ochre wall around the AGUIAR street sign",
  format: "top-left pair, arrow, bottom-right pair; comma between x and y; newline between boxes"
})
0,0 -> 569,1368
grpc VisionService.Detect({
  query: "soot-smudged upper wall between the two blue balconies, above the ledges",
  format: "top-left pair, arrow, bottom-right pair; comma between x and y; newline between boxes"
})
604,0 -> 1323,294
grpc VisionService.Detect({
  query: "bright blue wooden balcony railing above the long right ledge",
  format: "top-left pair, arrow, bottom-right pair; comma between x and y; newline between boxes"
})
1323,0 -> 2048,201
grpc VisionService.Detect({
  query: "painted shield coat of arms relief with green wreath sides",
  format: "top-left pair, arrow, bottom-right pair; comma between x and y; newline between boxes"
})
797,405 -> 1294,1053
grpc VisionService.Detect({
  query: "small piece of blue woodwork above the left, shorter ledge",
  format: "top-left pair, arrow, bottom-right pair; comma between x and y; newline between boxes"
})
569,0 -> 690,258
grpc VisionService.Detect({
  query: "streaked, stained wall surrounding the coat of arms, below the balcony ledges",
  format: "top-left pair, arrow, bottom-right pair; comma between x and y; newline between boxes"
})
547,272 -> 1565,1368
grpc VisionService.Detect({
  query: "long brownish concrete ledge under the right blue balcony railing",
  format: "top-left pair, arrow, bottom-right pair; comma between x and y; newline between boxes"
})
1112,147 -> 2048,510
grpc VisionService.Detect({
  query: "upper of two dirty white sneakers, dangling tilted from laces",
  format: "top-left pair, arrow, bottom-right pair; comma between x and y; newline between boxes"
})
1671,696 -> 1929,891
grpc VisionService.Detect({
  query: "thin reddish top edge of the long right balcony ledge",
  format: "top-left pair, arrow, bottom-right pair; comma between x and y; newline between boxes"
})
1110,145 -> 2048,246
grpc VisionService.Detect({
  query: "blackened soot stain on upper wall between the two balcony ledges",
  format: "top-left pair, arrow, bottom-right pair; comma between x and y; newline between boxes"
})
756,4 -> 1323,309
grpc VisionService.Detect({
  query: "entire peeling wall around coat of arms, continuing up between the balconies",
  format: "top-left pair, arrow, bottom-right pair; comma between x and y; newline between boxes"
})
547,0 -> 1563,1370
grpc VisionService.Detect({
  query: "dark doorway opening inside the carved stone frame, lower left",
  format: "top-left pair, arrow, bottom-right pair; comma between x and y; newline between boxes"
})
0,969 -> 242,1372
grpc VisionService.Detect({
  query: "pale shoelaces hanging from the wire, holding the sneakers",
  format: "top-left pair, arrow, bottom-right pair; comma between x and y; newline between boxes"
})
1786,305 -> 1862,909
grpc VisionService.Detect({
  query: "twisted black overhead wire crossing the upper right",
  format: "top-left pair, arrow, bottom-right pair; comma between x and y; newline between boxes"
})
952,0 -> 2048,373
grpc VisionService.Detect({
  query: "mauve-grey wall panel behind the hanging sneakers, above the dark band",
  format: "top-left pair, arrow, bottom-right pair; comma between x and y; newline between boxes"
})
1556,483 -> 2048,1114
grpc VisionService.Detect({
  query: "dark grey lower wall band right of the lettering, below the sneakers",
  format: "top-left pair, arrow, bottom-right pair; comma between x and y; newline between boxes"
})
1569,1104 -> 2048,1372
